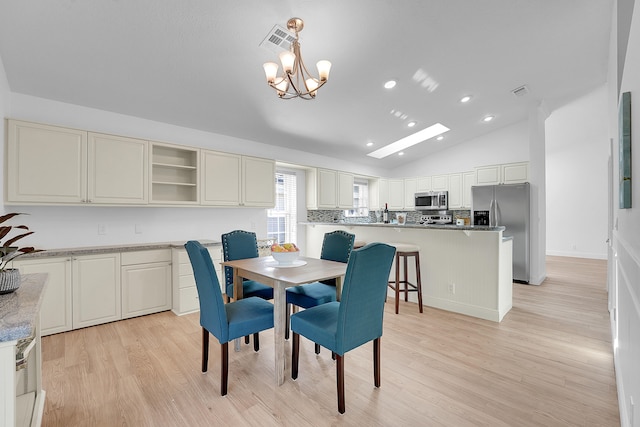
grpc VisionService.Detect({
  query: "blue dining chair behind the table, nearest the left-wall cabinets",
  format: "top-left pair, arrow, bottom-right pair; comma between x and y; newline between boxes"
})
222,230 -> 273,301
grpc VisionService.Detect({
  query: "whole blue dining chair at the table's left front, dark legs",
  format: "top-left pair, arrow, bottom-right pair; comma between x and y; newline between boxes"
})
184,240 -> 273,396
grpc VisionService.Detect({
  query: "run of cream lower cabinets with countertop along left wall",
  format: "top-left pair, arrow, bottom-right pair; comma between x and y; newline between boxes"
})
13,247 -> 172,336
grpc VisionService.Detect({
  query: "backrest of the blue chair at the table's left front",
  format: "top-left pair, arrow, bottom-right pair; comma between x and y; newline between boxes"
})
184,240 -> 229,343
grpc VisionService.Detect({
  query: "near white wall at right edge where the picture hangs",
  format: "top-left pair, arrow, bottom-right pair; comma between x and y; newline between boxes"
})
609,0 -> 640,427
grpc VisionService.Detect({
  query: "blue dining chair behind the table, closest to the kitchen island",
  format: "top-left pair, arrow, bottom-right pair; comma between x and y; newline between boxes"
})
285,230 -> 356,354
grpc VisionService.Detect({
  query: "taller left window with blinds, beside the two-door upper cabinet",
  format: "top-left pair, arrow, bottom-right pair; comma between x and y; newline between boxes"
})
267,172 -> 298,243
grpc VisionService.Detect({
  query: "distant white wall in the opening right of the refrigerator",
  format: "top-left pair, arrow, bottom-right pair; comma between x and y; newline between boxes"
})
546,86 -> 609,259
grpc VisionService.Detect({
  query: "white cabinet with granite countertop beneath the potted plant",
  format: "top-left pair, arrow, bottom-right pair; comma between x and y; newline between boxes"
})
0,274 -> 47,427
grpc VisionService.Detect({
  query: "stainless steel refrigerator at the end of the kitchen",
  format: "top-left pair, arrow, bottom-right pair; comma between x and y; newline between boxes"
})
471,182 -> 531,283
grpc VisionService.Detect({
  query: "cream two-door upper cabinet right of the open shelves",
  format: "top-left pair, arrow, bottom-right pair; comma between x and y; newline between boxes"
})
201,150 -> 276,208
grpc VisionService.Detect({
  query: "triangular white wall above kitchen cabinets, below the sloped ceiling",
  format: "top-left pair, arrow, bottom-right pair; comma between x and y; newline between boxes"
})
391,120 -> 529,178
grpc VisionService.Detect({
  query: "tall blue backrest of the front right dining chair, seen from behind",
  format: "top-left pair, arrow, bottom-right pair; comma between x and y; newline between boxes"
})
336,243 -> 396,355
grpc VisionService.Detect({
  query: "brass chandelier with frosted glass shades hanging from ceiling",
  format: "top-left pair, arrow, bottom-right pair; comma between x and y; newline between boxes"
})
263,18 -> 331,99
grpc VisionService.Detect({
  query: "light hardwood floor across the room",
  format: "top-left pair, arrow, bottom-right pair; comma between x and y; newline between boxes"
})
42,257 -> 620,427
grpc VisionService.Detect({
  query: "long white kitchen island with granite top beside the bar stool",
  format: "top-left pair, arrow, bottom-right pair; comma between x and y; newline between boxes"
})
304,222 -> 513,322
